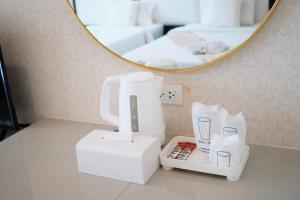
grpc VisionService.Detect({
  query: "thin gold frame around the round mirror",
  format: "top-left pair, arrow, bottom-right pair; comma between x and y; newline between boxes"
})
64,0 -> 281,73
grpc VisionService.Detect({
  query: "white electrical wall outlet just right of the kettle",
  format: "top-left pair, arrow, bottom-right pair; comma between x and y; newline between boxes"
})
160,85 -> 183,105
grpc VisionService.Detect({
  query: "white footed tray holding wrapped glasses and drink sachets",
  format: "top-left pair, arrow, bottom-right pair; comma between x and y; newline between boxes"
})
160,136 -> 249,181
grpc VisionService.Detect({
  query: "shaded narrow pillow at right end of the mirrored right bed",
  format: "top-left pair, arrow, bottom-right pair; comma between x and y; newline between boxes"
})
241,0 -> 256,25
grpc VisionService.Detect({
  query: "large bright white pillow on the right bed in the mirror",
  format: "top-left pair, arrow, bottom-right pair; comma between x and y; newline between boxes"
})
207,0 -> 243,27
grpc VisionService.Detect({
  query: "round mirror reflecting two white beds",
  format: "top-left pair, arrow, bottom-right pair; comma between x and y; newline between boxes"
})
66,0 -> 279,71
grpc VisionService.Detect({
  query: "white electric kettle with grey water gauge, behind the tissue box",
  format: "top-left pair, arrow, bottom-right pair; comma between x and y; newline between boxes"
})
100,72 -> 165,144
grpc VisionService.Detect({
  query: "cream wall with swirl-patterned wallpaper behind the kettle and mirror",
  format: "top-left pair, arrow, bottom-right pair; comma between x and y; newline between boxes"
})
0,0 -> 300,148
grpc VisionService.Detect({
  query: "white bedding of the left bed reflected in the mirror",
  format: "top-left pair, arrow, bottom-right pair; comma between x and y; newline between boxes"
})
86,24 -> 163,55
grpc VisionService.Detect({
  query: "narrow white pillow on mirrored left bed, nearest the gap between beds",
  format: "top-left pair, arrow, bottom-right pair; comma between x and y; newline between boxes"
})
136,2 -> 154,26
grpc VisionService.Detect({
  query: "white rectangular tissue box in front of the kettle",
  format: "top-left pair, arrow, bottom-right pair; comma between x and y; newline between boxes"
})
76,130 -> 161,184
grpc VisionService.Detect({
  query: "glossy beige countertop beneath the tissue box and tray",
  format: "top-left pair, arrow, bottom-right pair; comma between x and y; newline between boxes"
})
0,119 -> 300,200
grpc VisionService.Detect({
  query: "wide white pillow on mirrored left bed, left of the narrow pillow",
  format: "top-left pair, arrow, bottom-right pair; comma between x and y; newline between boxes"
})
105,1 -> 139,26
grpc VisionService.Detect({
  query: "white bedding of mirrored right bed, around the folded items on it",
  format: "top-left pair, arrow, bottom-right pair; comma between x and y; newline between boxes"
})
123,24 -> 257,68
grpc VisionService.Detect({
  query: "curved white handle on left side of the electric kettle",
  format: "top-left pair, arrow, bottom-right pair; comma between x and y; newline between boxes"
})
100,76 -> 120,126
